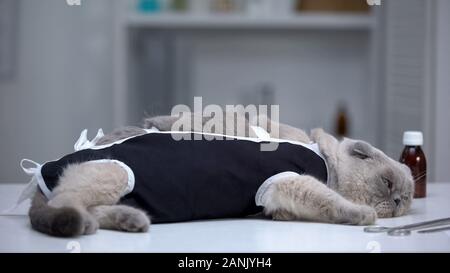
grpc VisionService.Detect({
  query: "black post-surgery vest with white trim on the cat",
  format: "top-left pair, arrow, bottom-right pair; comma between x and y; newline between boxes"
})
18,127 -> 328,223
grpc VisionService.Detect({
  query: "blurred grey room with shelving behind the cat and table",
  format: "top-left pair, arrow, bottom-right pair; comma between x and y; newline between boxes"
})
0,0 -> 450,183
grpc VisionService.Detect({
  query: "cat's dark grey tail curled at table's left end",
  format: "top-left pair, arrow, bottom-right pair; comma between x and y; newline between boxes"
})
28,190 -> 83,237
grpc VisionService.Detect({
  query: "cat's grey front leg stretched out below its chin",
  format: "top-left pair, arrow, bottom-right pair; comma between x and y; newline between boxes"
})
263,175 -> 377,225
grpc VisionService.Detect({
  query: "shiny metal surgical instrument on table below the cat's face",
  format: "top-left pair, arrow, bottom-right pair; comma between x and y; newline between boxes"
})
364,218 -> 450,236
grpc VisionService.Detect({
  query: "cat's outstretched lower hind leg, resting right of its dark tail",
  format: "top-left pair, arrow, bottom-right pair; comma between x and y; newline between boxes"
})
88,205 -> 150,232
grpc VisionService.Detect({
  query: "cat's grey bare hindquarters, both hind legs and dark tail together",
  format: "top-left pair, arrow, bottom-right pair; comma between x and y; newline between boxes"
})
29,160 -> 150,237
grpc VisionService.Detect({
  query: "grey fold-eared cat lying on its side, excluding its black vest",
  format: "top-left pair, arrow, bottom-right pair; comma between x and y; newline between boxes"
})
29,110 -> 414,237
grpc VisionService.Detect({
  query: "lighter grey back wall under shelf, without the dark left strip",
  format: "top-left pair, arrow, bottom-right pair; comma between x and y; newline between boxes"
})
190,30 -> 370,140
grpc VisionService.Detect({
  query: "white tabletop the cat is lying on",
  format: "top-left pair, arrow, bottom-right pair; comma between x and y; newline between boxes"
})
0,183 -> 450,252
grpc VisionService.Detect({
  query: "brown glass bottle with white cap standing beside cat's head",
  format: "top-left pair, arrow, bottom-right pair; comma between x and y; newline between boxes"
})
400,131 -> 427,198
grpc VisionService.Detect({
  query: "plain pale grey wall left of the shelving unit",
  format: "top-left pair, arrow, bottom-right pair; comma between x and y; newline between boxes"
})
0,0 -> 113,183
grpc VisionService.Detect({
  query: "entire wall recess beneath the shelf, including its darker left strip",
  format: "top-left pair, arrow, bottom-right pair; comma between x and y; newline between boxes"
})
133,29 -> 377,144
